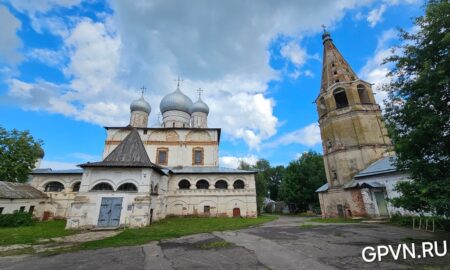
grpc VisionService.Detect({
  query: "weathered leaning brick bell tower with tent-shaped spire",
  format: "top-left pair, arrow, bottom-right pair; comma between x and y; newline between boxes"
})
316,31 -> 391,217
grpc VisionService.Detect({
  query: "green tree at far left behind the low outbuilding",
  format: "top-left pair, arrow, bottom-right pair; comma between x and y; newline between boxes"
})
0,127 -> 43,183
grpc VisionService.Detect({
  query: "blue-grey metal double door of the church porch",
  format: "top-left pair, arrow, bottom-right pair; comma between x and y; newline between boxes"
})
98,198 -> 122,227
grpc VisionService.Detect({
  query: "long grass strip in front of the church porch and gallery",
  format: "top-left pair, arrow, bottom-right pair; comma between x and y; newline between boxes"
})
79,216 -> 277,249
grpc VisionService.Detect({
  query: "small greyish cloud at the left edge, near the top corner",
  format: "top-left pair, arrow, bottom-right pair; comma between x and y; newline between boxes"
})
0,6 -> 22,64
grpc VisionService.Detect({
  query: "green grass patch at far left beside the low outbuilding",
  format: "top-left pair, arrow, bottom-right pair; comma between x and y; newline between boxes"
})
0,220 -> 77,246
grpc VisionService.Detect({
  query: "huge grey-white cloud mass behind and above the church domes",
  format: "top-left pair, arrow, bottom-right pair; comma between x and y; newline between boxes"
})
10,0 -> 378,149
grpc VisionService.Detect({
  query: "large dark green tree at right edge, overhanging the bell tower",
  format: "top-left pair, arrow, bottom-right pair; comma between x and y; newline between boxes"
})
385,1 -> 450,216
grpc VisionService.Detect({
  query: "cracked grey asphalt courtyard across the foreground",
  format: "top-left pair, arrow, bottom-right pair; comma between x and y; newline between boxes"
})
0,217 -> 450,270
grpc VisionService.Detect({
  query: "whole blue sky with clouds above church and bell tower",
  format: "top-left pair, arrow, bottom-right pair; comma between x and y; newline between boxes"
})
0,0 -> 423,168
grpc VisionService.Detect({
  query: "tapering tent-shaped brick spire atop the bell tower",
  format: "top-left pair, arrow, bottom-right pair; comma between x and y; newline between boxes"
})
320,29 -> 358,92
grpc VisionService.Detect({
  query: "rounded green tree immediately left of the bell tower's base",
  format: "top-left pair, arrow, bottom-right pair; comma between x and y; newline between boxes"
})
281,151 -> 326,211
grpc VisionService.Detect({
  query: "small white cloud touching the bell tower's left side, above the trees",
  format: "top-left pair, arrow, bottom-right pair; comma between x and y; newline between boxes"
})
264,123 -> 322,148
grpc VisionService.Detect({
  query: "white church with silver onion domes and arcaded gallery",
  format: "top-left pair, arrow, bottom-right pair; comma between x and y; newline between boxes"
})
31,86 -> 257,228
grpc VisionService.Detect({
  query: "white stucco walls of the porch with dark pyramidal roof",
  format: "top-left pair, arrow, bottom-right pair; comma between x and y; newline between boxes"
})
66,168 -> 167,228
